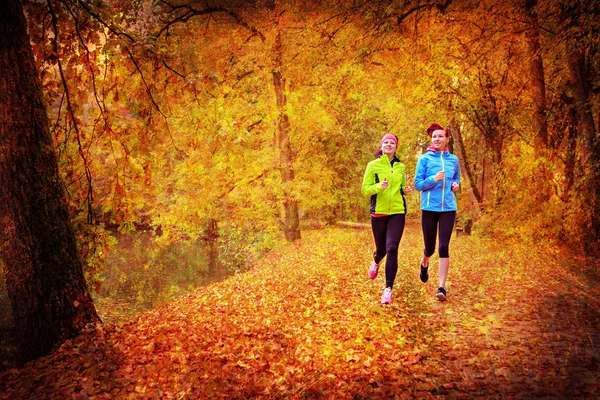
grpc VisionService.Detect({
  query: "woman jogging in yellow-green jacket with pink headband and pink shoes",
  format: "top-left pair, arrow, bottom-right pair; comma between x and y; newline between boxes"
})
362,134 -> 412,304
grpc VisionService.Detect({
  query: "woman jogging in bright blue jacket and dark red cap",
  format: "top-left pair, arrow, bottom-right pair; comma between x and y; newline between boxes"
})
415,124 -> 460,301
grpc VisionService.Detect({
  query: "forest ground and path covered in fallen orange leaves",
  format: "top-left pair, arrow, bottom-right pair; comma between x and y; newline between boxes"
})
0,220 -> 600,399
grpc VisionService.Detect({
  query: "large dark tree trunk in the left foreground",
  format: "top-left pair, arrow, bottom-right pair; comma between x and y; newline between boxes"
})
0,0 -> 99,362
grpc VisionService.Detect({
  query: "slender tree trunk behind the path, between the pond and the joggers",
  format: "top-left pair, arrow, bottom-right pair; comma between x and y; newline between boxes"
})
273,16 -> 300,241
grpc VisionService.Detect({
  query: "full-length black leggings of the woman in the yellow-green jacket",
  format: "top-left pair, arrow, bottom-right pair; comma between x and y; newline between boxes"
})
371,214 -> 406,288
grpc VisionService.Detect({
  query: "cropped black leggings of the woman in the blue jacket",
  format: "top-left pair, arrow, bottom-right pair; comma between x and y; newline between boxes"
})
421,211 -> 456,258
